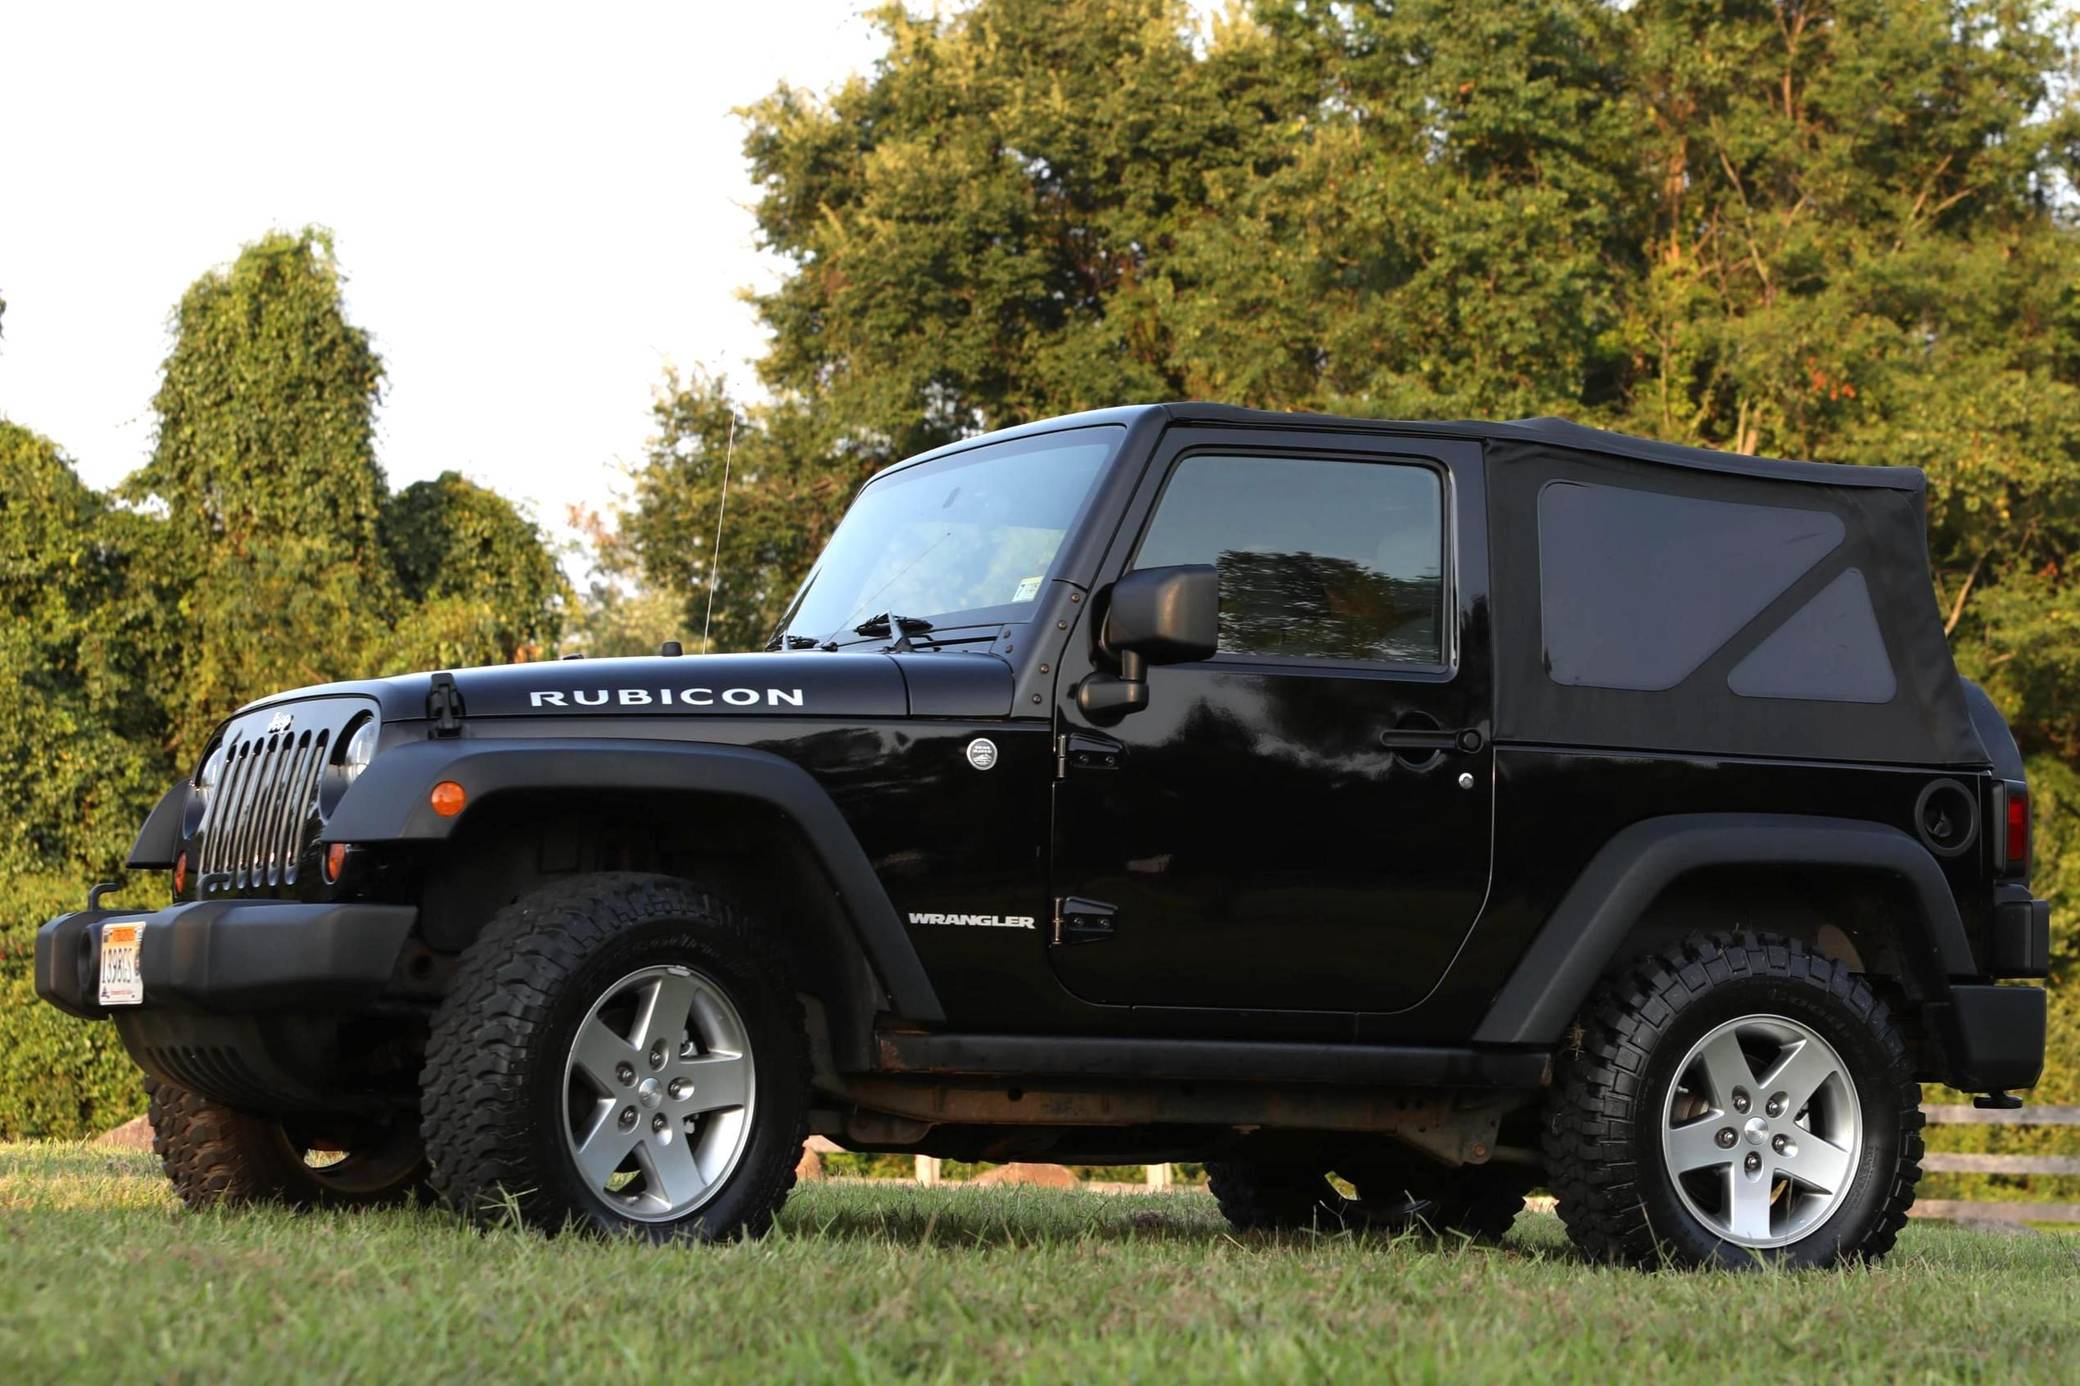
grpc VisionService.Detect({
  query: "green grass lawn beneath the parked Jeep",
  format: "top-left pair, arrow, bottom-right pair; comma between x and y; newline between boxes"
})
0,1145 -> 2080,1386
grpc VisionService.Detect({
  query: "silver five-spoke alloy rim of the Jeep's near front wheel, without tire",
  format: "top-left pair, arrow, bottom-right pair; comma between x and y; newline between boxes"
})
564,966 -> 755,1222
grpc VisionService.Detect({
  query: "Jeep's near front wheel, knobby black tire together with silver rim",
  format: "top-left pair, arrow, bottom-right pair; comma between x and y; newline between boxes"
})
422,874 -> 807,1240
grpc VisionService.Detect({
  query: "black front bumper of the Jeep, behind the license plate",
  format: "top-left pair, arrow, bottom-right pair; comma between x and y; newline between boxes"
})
35,899 -> 418,1020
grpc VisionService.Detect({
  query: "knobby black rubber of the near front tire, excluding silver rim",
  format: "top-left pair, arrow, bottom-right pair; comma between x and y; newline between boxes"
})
420,872 -> 809,1240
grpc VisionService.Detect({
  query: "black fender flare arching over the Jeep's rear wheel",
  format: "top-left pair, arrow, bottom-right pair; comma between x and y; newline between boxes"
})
1473,814 -> 1978,1045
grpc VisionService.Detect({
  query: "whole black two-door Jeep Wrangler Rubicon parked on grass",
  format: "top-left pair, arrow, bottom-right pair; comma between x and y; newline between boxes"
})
35,404 -> 2049,1263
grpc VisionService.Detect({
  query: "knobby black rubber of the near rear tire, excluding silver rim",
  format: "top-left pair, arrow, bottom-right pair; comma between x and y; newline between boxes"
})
1543,932 -> 1922,1267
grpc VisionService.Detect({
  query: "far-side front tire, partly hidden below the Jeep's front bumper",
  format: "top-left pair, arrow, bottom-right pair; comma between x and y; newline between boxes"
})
146,1078 -> 428,1209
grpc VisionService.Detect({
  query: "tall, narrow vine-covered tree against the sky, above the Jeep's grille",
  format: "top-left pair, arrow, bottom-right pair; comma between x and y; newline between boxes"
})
125,231 -> 397,755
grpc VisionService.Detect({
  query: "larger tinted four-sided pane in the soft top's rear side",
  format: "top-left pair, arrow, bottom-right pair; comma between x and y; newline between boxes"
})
1539,481 -> 1843,689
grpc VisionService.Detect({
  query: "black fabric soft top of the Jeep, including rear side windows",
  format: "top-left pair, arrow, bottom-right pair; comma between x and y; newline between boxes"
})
902,404 -> 1988,766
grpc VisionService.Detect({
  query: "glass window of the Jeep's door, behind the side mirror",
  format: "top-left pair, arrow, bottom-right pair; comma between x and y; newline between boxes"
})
1134,454 -> 1444,664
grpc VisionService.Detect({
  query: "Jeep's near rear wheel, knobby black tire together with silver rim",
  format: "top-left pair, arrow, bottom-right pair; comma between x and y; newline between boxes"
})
1545,936 -> 1922,1265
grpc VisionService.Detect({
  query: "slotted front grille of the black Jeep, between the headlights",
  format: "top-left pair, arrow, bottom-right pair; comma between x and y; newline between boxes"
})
196,699 -> 372,899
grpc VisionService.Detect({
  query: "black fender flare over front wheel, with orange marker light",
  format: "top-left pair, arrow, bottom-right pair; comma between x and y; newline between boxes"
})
318,737 -> 946,1020
